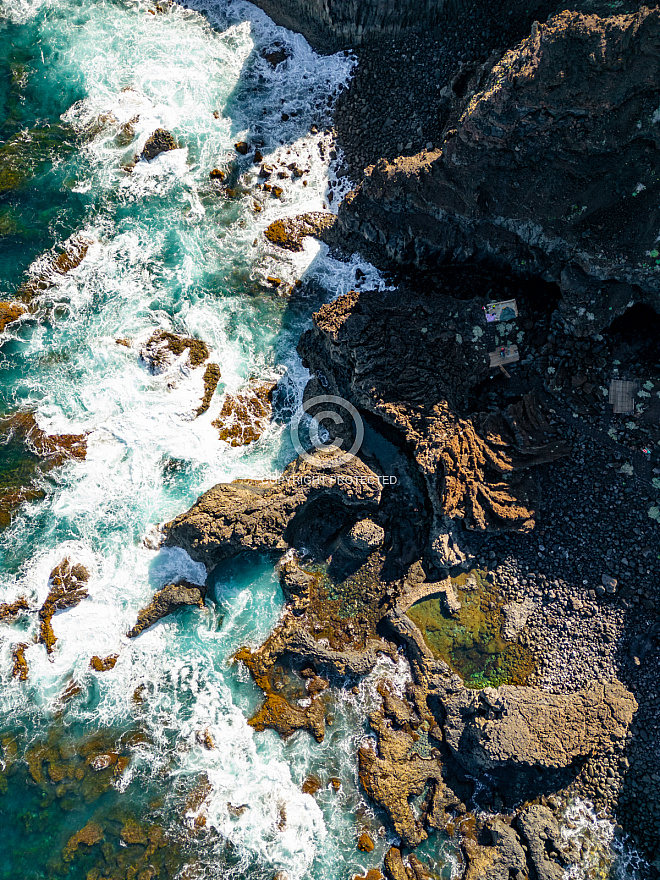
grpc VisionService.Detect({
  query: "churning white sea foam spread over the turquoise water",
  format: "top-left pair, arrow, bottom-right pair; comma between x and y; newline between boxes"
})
0,0 -> 375,880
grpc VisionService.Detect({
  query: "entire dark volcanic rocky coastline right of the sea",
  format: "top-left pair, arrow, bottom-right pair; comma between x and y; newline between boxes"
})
159,3 -> 660,880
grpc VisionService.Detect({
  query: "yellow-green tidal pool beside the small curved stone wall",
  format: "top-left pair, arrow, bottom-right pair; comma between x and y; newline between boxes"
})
407,572 -> 534,688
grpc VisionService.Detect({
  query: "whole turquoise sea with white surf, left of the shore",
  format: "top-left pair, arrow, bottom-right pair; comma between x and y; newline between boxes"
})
0,0 -> 644,880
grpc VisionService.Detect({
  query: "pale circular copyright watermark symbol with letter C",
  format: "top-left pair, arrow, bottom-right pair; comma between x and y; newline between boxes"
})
290,394 -> 364,467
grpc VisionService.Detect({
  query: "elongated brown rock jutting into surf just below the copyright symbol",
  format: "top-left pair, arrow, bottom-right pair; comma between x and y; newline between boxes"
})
165,455 -> 381,569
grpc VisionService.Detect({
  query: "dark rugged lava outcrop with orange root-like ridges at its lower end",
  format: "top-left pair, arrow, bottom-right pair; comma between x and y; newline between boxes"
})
298,290 -> 567,567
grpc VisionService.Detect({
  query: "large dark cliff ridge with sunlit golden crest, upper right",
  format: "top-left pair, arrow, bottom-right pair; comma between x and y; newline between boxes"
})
339,7 -> 660,333
